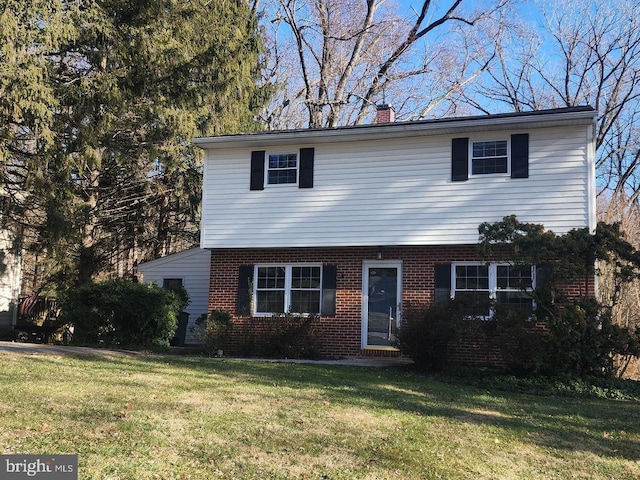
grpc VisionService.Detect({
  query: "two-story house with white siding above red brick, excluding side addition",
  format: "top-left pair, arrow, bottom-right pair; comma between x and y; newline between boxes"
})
195,107 -> 596,360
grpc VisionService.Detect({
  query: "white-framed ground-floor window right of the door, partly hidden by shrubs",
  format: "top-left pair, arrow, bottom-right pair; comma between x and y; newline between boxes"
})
452,263 -> 535,317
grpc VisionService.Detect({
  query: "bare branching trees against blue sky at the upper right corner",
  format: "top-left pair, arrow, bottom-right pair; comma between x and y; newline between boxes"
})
464,0 -> 640,202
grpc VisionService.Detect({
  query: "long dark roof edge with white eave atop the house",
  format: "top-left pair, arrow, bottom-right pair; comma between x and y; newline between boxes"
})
193,105 -> 597,148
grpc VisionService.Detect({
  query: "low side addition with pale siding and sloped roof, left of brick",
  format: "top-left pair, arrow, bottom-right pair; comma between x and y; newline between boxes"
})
136,248 -> 211,345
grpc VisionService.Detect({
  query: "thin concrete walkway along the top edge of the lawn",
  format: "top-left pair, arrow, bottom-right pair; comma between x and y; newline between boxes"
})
0,341 -> 413,367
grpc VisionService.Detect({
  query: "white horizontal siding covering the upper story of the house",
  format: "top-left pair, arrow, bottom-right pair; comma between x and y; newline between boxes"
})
201,125 -> 594,248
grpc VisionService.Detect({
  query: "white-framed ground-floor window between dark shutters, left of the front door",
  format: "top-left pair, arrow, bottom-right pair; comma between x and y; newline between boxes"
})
254,265 -> 322,315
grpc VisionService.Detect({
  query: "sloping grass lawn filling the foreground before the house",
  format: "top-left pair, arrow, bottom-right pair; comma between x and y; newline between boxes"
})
0,353 -> 640,480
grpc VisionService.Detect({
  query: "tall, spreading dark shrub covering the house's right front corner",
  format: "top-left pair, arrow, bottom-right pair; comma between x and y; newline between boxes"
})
478,215 -> 640,377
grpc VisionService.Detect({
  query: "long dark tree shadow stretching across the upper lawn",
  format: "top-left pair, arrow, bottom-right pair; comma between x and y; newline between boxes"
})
12,355 -> 640,461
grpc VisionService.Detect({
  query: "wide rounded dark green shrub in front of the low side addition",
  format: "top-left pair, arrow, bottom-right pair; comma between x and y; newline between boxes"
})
61,280 -> 188,349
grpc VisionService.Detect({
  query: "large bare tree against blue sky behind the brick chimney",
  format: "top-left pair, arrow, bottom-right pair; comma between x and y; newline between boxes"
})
253,0 -> 508,129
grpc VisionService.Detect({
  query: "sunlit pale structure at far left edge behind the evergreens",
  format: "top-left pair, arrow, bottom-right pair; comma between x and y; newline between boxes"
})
0,228 -> 22,329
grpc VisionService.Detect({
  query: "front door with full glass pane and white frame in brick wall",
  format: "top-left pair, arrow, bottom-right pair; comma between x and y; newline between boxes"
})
362,261 -> 402,347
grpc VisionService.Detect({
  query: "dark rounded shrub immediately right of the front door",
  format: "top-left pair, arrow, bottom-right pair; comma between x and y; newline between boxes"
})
398,299 -> 475,372
